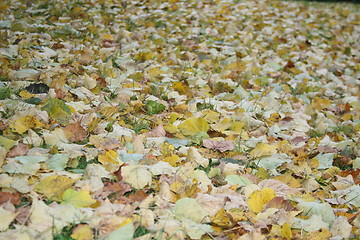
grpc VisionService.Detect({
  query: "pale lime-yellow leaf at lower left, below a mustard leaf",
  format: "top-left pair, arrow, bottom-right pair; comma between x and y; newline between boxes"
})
62,188 -> 96,208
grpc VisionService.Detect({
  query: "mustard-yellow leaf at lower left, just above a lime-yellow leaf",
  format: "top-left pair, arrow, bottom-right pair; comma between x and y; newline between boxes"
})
35,176 -> 76,201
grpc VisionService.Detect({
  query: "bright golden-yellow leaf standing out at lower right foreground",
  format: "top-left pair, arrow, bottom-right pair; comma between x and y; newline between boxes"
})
248,187 -> 276,213
